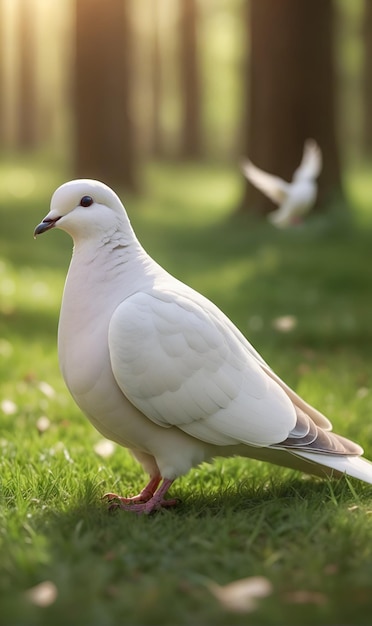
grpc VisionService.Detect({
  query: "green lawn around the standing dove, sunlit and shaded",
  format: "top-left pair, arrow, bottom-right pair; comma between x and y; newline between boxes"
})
0,160 -> 372,626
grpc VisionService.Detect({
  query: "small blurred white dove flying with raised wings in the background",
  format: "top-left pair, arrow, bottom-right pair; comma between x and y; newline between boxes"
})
242,139 -> 322,228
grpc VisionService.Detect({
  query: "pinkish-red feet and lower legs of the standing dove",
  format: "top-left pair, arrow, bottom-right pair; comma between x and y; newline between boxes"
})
103,476 -> 178,514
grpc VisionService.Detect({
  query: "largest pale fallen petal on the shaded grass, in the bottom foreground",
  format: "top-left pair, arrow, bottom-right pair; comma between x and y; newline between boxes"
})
208,576 -> 273,613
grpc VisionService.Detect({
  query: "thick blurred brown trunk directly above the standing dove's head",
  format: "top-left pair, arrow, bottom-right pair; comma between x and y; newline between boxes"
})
75,0 -> 136,189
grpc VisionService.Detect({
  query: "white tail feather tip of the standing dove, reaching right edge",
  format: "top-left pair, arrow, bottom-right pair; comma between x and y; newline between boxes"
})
292,451 -> 372,485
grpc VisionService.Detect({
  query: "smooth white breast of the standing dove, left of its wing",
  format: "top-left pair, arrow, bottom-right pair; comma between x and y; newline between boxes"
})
58,244 -> 157,447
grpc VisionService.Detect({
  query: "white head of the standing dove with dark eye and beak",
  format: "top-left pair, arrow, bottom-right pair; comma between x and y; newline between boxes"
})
34,179 -> 132,240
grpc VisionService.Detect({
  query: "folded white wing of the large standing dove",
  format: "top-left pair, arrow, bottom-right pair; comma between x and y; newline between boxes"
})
109,290 -> 296,446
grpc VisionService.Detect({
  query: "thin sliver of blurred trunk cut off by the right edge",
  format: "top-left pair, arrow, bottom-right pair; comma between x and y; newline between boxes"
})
362,0 -> 372,159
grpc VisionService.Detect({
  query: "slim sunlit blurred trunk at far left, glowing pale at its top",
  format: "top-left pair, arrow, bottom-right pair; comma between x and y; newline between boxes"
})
16,0 -> 37,150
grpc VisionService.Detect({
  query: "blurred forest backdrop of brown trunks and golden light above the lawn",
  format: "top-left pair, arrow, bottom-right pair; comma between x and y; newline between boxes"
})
0,0 -> 372,212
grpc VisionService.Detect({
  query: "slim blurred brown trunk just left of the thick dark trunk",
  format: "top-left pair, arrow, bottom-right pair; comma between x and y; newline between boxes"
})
179,0 -> 202,159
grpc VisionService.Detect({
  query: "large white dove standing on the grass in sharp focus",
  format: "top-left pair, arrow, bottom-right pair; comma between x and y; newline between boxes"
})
34,180 -> 372,513
